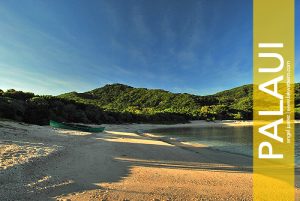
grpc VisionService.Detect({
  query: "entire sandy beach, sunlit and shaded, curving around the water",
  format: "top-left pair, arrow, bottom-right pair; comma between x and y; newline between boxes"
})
0,121 -> 299,201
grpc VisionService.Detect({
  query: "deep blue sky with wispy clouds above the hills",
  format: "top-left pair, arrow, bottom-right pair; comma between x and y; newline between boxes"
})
0,0 -> 300,95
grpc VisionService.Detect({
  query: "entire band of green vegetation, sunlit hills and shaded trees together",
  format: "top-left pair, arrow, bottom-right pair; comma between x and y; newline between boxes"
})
0,84 -> 300,124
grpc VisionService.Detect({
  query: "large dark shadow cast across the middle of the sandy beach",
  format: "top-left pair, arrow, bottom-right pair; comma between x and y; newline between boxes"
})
0,125 -> 252,200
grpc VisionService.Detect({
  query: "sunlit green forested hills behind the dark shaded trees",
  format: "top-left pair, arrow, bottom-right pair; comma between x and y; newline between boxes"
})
59,84 -> 252,120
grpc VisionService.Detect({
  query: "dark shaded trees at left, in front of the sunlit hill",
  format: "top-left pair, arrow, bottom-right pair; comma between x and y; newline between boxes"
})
0,89 -> 187,125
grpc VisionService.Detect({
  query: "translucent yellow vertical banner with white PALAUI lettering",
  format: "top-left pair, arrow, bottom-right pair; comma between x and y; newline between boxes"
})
253,0 -> 295,201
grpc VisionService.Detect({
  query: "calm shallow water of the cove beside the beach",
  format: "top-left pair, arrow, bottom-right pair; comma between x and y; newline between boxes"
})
150,124 -> 300,165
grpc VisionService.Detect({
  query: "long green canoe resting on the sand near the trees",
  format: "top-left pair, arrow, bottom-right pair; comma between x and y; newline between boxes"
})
50,120 -> 105,133
